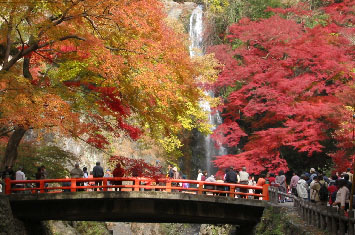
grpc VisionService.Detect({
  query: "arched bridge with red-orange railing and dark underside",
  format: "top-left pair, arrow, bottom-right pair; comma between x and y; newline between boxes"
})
5,177 -> 269,231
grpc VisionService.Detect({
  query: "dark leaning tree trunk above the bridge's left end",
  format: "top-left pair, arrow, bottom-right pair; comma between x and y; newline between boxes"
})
0,127 -> 27,169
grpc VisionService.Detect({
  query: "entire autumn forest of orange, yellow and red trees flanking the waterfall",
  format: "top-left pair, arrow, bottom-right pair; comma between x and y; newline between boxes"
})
0,0 -> 355,174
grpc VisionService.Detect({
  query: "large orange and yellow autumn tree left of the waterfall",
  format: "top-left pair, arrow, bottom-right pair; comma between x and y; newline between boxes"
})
0,0 -> 214,169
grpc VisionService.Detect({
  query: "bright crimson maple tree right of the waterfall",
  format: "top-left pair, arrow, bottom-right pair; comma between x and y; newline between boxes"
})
210,1 -> 354,173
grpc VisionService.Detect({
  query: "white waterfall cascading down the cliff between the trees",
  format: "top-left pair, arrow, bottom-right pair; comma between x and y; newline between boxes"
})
189,5 -> 227,175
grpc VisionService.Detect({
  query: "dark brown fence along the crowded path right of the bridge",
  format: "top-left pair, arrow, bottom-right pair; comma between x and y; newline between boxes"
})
269,187 -> 355,235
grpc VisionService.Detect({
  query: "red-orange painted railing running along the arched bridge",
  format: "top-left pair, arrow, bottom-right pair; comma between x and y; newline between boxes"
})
5,177 -> 269,200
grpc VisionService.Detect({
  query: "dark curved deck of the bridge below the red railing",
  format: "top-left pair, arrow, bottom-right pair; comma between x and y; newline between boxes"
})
8,191 -> 266,225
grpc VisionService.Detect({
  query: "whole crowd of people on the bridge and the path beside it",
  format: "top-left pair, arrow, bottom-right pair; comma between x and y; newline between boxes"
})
0,162 -> 353,210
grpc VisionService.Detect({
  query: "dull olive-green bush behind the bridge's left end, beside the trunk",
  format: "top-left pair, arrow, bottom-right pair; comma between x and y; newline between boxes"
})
2,143 -> 78,179
